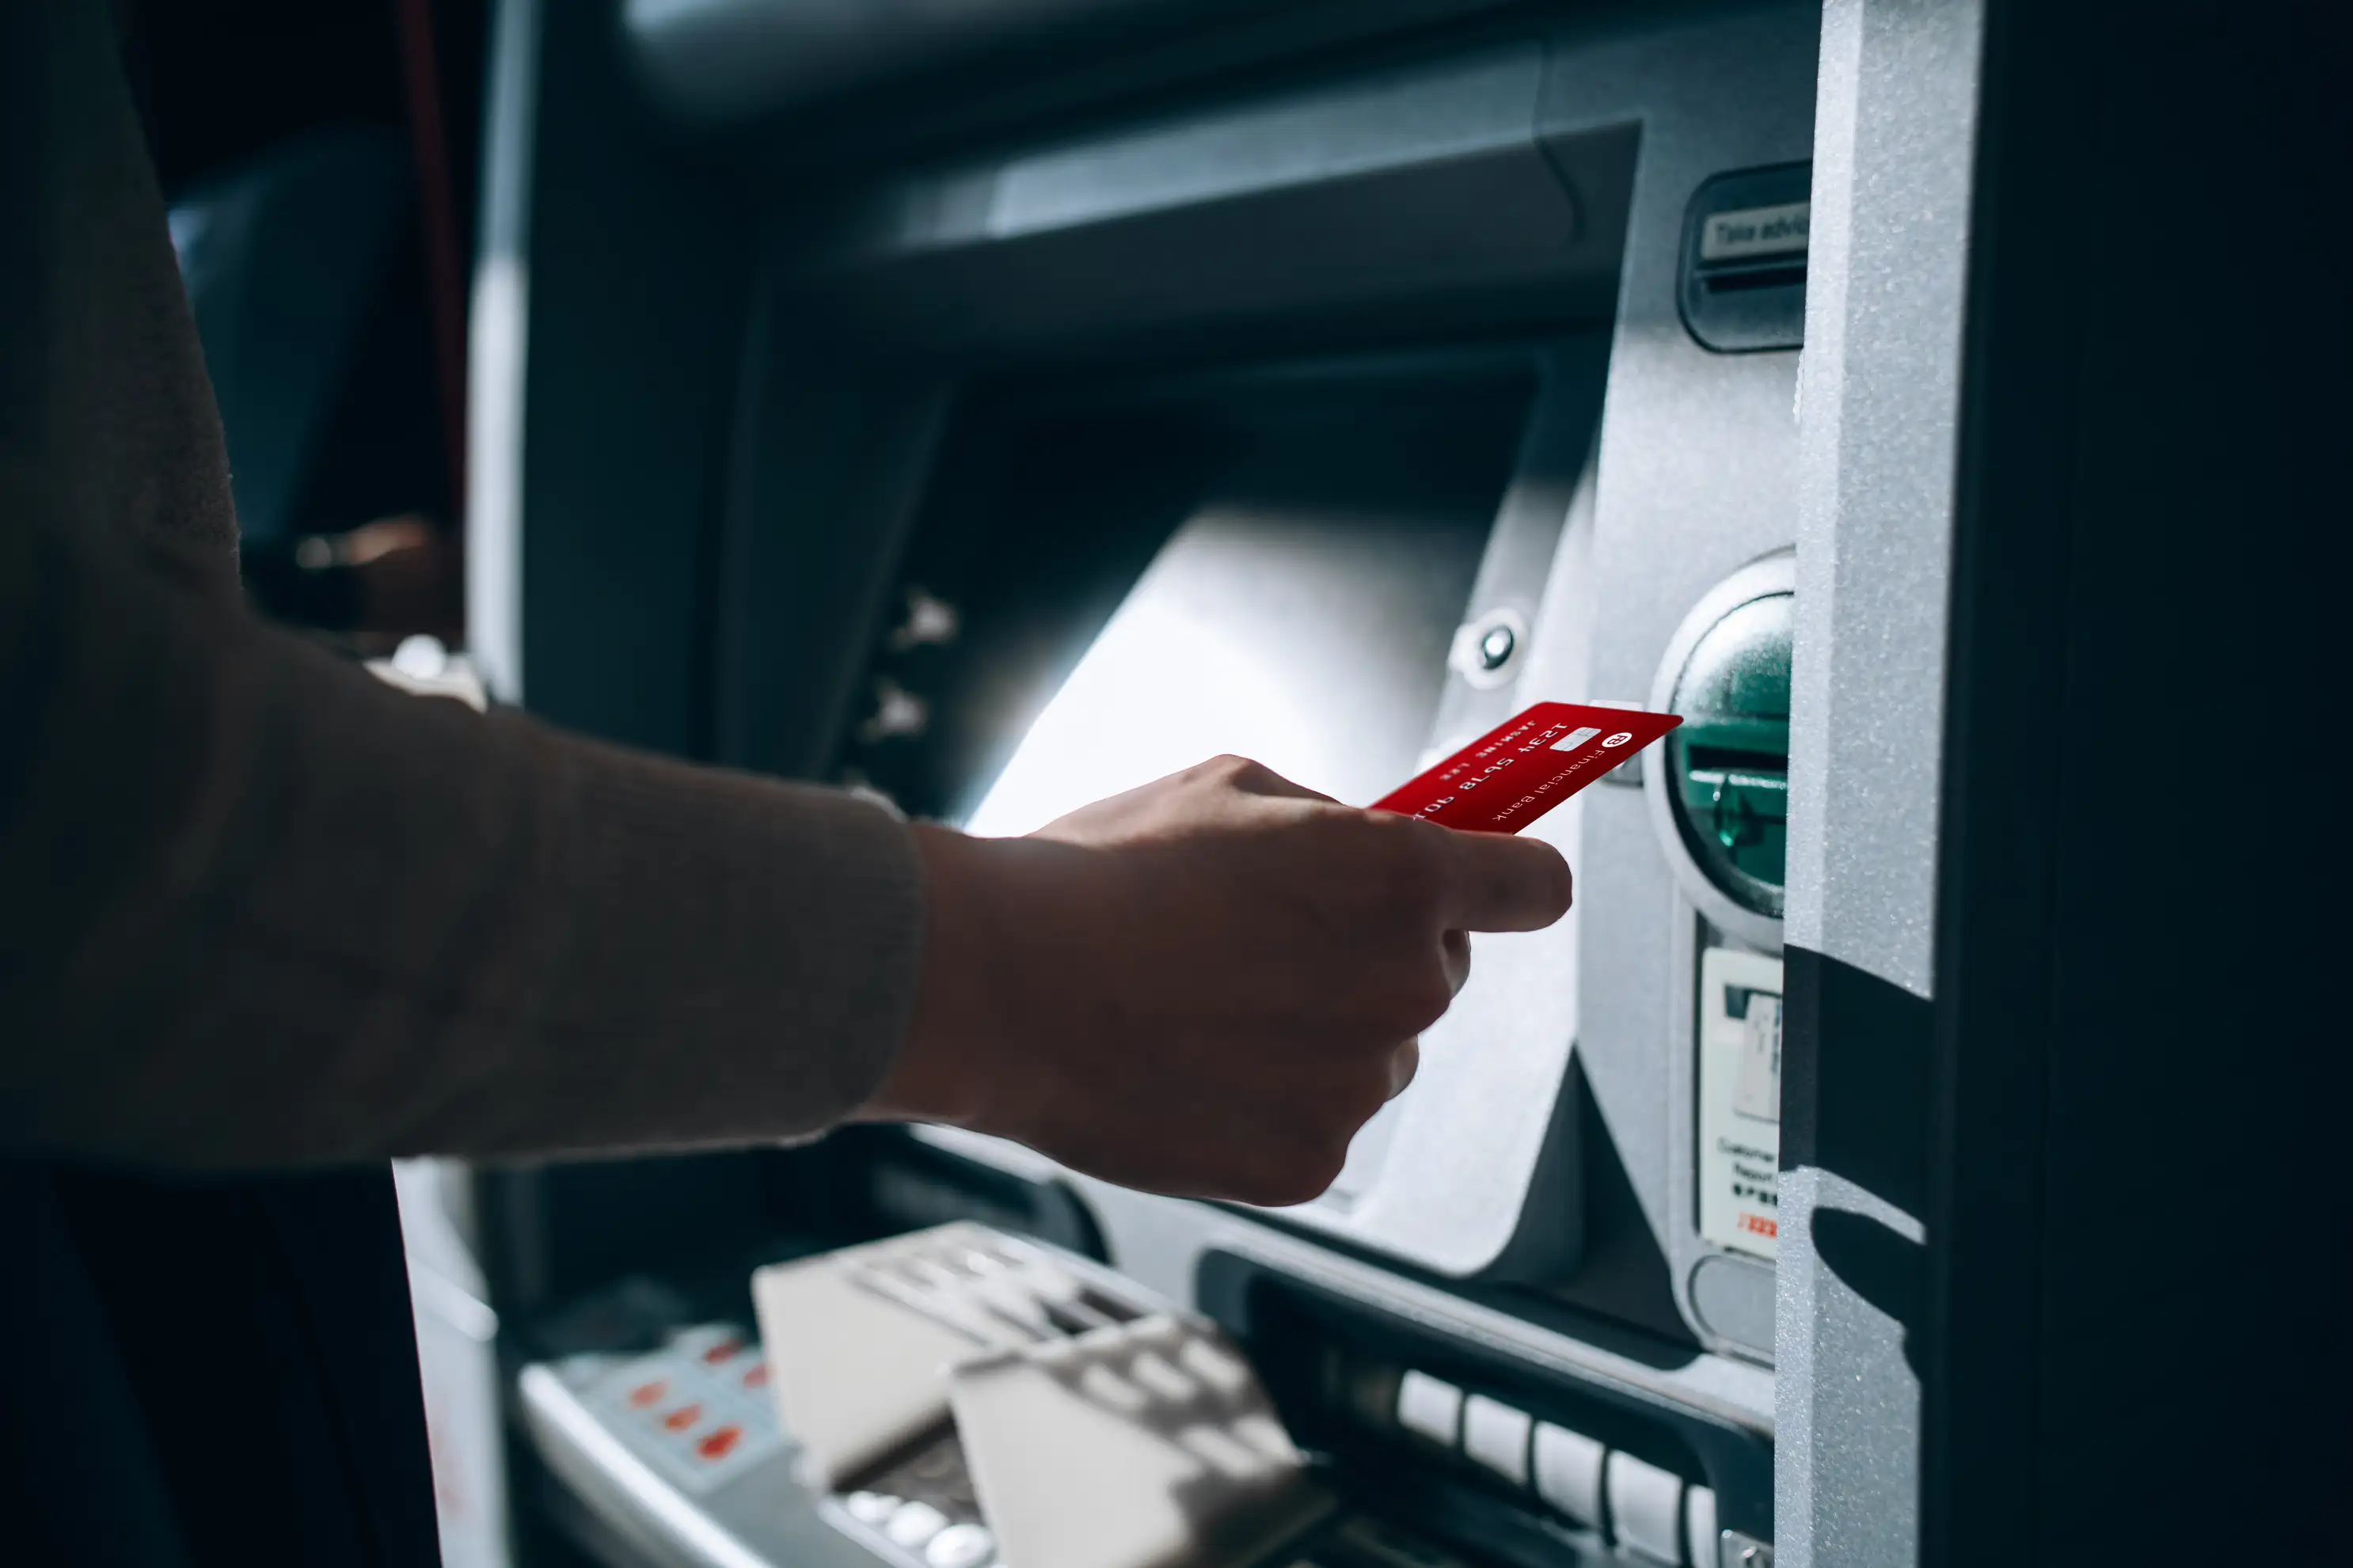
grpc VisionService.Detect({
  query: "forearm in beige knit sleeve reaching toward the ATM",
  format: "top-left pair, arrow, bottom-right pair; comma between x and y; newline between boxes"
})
0,526 -> 922,1166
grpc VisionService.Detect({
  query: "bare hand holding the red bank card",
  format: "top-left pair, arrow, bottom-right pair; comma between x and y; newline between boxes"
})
864,757 -> 1569,1204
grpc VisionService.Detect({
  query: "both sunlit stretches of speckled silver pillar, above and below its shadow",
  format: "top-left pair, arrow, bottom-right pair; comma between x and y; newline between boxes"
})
1774,0 -> 1981,1568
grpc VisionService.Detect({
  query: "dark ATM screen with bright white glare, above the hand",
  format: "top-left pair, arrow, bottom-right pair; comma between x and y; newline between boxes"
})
852,371 -> 1530,834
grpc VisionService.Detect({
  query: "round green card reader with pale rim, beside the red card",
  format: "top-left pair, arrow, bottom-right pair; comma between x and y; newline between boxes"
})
1649,552 -> 1796,950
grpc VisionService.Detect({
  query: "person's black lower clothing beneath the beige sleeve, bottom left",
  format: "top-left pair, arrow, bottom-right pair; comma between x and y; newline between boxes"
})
41,1166 -> 440,1568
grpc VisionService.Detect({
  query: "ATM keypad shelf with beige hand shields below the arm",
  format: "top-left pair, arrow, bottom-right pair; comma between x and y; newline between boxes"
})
518,1222 -> 1647,1568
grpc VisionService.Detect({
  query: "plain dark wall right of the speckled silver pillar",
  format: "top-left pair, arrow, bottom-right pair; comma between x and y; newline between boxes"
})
1922,0 -> 2343,1566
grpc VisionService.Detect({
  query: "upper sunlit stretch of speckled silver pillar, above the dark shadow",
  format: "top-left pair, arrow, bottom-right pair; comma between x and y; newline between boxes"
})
1786,0 -> 1979,997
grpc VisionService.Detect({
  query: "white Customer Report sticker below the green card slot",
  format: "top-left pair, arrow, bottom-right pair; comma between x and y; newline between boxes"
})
1699,947 -> 1781,1262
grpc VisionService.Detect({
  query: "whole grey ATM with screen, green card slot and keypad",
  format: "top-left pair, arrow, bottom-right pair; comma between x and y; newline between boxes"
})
409,0 -> 2061,1568
